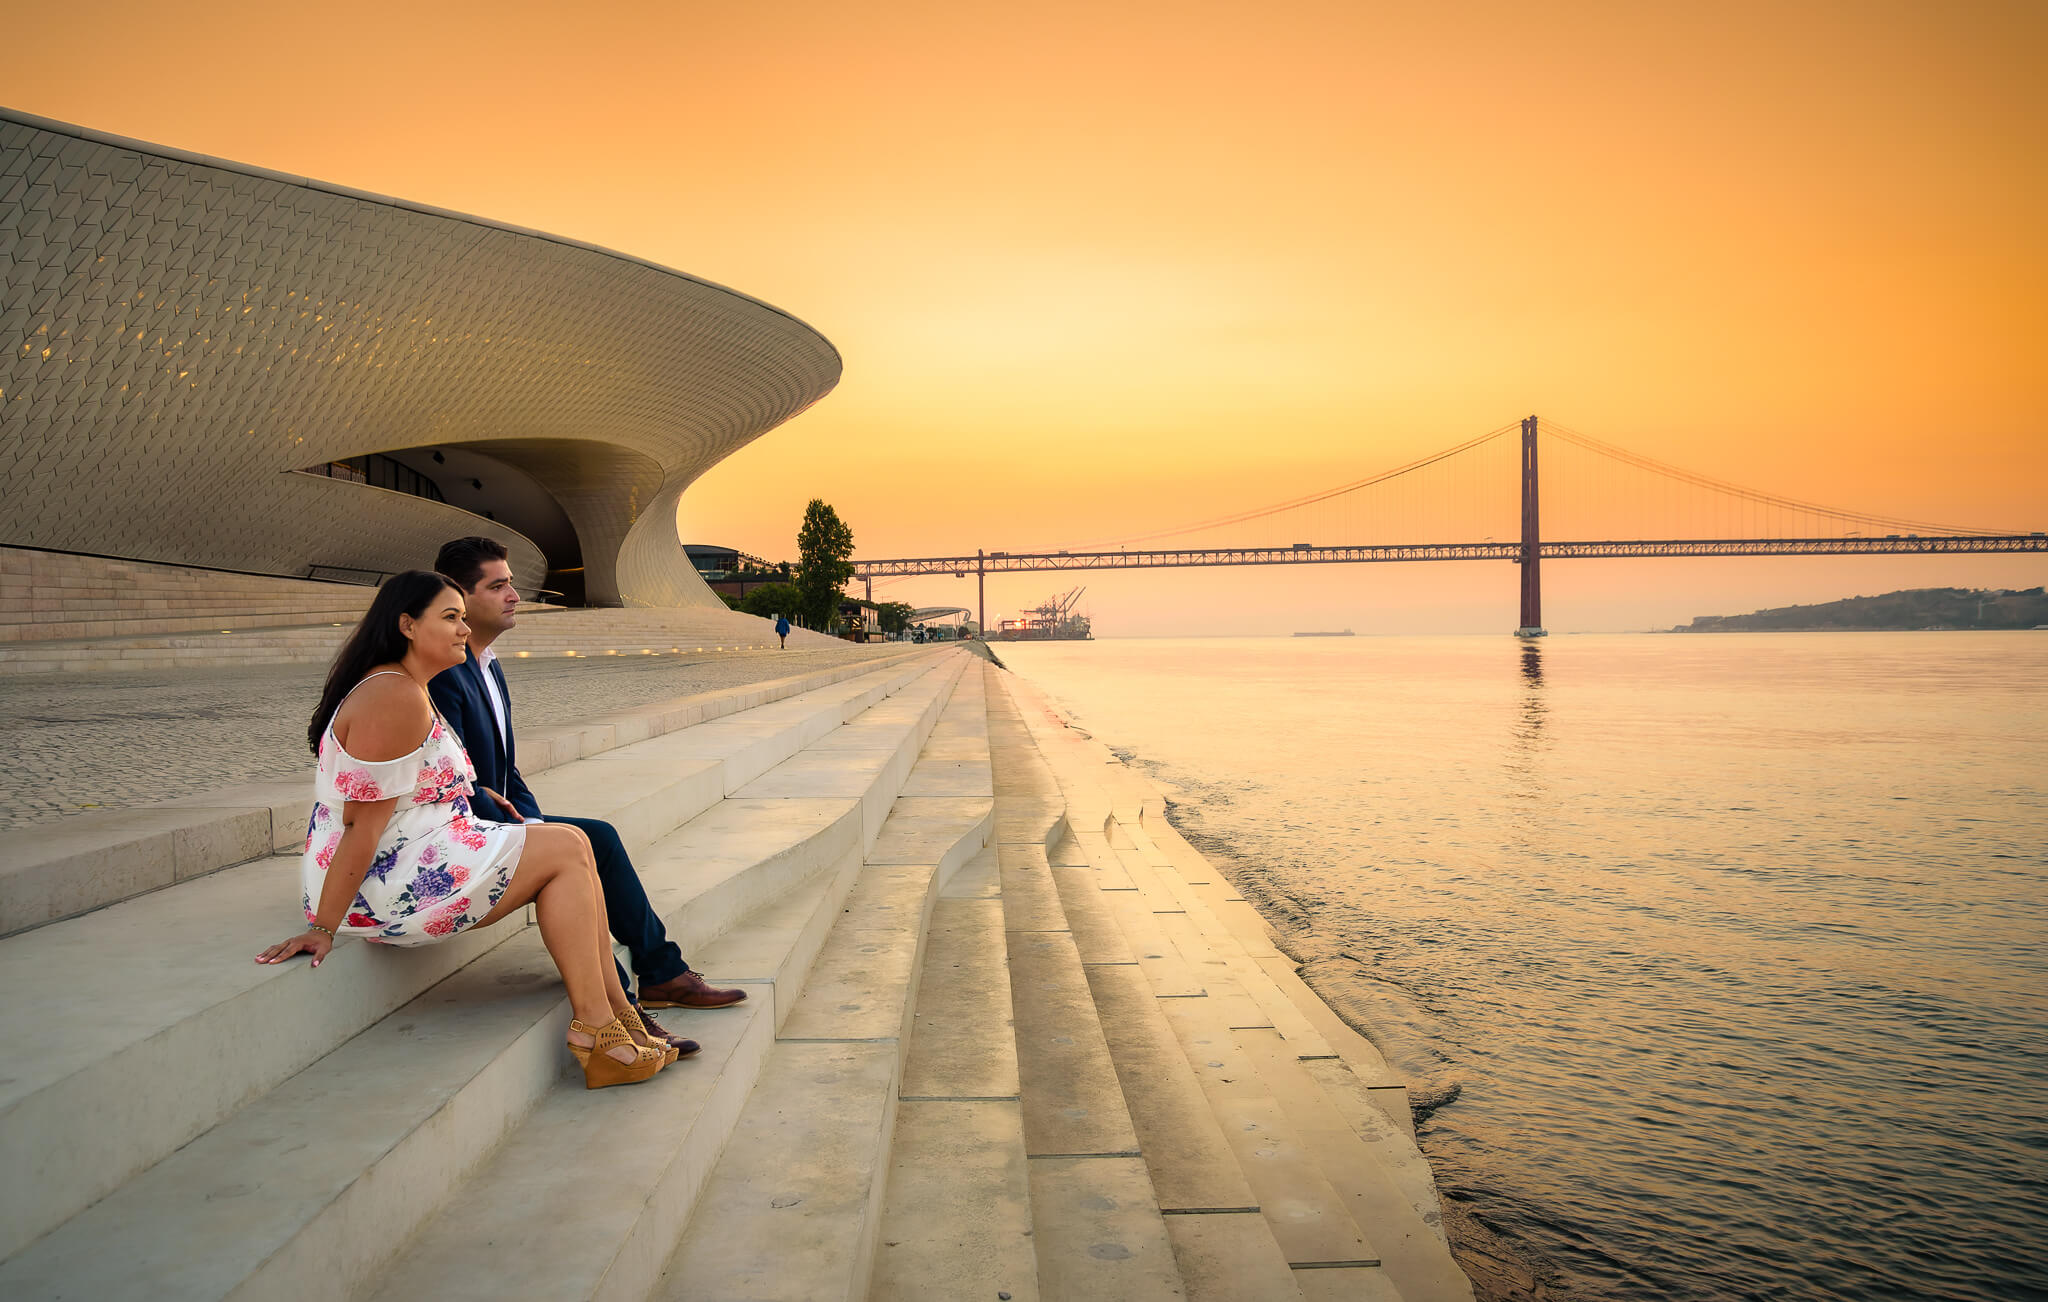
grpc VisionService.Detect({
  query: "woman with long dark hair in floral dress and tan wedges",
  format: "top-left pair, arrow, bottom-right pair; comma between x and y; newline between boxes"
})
256,569 -> 676,1089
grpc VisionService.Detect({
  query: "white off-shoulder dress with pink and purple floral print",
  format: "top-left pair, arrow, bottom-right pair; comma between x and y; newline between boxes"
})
299,669 -> 526,946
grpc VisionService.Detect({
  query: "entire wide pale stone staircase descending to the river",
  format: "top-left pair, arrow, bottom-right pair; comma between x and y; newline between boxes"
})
0,649 -> 1470,1302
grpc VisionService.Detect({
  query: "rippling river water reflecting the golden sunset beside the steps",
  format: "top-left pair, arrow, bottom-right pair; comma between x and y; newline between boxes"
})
997,633 -> 2048,1302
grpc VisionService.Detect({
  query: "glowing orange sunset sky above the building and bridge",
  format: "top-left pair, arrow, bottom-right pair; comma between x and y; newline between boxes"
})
0,0 -> 2048,633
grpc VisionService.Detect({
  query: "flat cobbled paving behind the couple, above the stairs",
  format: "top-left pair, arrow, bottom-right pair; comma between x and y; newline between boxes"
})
0,643 -> 905,829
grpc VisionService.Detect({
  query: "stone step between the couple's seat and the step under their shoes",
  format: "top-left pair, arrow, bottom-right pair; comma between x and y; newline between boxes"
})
0,798 -> 860,1298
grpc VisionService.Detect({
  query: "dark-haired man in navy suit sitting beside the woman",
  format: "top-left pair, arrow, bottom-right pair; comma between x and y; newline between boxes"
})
428,538 -> 748,1056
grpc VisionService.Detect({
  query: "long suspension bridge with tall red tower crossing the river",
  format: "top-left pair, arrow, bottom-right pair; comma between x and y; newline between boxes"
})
854,416 -> 2048,637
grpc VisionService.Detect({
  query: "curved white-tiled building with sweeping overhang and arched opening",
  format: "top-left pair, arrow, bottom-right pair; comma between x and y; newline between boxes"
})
0,109 -> 840,608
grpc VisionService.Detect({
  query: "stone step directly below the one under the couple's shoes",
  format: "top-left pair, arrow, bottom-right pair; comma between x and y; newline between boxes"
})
655,675 -> 993,1302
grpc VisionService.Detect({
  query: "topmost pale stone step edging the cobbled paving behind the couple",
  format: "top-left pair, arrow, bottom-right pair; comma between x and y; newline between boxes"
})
0,651 -> 938,936
